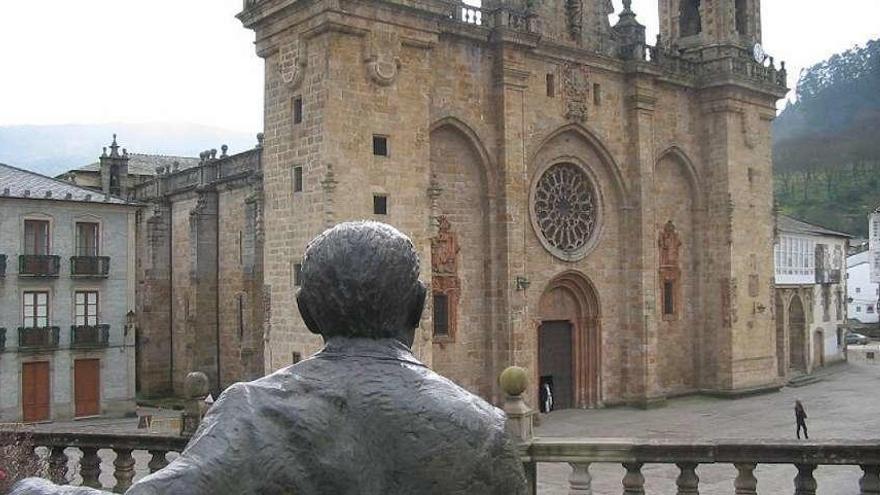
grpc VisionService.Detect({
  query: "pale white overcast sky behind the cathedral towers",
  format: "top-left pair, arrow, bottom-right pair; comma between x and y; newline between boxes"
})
0,0 -> 880,132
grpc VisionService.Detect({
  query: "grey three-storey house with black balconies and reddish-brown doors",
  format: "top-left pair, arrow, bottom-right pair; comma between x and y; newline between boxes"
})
0,163 -> 137,422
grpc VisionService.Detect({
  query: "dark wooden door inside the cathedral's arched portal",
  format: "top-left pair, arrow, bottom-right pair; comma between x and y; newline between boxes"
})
538,321 -> 574,409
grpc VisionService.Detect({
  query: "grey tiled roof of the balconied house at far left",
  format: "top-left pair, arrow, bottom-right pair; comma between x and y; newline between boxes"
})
0,163 -> 135,205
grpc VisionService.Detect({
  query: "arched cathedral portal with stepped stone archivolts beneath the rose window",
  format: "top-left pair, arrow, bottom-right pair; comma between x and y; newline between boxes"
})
536,272 -> 602,409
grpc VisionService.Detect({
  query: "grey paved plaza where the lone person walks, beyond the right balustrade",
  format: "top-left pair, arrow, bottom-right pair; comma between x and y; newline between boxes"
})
537,364 -> 880,495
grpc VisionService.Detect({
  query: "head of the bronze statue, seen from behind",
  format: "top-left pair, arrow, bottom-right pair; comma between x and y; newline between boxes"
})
296,222 -> 426,346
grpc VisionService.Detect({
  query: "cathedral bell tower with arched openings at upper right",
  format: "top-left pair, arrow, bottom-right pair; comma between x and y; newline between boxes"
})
660,0 -> 761,50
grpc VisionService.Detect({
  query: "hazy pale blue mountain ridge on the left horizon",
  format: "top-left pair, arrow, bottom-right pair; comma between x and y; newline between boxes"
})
0,123 -> 257,176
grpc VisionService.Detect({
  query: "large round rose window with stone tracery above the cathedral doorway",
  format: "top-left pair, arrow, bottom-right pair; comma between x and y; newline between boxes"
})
530,163 -> 600,261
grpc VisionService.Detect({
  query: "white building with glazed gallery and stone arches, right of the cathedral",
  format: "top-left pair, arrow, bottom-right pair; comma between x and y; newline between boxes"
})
774,215 -> 850,378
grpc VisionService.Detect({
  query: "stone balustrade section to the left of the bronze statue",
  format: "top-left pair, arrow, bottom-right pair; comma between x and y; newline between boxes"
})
4,431 -> 188,493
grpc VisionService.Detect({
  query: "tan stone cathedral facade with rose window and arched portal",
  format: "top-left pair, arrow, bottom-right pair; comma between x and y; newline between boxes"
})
239,0 -> 787,407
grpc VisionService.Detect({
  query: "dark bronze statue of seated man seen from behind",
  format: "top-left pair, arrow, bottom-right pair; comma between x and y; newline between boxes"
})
12,222 -> 526,495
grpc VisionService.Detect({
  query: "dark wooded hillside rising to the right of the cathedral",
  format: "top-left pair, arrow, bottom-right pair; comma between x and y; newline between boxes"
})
773,40 -> 880,236
